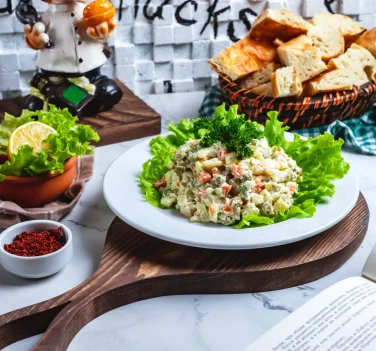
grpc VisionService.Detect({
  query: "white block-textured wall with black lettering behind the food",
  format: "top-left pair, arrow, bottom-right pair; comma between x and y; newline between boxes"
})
0,0 -> 376,98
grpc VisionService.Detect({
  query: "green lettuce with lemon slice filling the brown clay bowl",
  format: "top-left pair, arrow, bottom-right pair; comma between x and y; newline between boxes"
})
0,105 -> 99,181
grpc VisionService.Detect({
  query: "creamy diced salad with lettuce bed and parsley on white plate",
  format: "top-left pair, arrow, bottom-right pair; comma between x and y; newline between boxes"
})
139,104 -> 350,228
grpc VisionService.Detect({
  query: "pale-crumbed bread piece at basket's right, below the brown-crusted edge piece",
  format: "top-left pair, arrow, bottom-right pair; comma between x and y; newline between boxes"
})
328,44 -> 376,80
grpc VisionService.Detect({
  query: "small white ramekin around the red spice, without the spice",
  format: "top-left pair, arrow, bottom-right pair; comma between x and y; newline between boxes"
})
0,220 -> 73,278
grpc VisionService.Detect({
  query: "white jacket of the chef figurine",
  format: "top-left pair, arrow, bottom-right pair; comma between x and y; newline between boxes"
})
37,2 -> 107,74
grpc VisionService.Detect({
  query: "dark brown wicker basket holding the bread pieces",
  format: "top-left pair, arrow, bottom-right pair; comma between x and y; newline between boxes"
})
219,76 -> 376,130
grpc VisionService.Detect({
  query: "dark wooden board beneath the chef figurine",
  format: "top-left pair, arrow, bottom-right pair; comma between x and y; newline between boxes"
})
0,80 -> 161,146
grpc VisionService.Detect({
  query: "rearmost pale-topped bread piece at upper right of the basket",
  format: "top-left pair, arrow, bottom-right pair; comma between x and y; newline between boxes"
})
312,12 -> 365,48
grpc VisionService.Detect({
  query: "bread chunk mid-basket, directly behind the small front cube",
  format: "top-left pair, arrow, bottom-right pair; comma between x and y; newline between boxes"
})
277,35 -> 326,82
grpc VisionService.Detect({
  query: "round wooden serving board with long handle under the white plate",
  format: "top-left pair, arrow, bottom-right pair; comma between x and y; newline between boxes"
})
0,194 -> 369,351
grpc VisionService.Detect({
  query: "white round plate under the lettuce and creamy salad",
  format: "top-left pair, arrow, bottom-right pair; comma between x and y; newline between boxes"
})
103,133 -> 359,250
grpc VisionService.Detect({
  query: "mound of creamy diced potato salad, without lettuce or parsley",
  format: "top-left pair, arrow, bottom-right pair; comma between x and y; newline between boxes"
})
155,137 -> 302,225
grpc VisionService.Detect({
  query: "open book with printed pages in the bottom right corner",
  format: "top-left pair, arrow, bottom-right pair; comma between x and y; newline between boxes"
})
244,246 -> 376,351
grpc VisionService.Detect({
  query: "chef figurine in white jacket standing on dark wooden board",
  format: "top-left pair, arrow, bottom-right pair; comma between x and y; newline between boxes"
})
16,0 -> 123,115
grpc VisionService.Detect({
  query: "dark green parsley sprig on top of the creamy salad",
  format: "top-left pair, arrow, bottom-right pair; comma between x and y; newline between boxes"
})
193,104 -> 263,159
